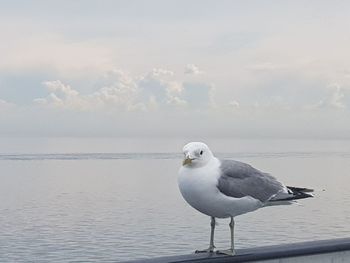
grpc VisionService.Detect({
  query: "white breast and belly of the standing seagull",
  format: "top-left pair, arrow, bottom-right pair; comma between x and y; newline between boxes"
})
178,158 -> 261,218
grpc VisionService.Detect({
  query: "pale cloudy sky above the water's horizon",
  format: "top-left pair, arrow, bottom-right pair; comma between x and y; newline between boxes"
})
0,0 -> 350,139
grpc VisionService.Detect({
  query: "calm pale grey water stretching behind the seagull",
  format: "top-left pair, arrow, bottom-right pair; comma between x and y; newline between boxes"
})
0,138 -> 350,262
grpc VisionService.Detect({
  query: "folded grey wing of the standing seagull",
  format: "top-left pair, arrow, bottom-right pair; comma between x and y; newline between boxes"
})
217,160 -> 284,202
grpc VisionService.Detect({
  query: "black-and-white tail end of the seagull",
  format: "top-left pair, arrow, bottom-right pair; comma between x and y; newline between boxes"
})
268,186 -> 314,205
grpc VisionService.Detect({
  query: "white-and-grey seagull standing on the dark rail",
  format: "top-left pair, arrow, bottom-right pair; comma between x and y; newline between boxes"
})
178,142 -> 313,255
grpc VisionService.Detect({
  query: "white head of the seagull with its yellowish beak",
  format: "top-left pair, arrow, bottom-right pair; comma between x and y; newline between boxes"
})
182,142 -> 213,167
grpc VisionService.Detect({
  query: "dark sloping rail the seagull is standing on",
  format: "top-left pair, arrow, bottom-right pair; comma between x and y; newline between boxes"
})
121,238 -> 350,263
